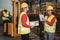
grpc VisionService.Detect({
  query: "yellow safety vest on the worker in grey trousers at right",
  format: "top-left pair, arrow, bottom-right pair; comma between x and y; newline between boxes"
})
44,15 -> 57,33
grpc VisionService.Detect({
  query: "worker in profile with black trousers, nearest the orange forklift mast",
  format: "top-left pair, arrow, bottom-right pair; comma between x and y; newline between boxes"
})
18,2 -> 30,40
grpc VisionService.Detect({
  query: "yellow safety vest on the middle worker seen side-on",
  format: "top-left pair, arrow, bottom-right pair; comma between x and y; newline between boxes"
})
18,12 -> 30,34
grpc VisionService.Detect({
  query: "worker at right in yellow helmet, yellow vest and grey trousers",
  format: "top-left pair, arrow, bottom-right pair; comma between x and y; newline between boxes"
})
44,6 -> 57,40
